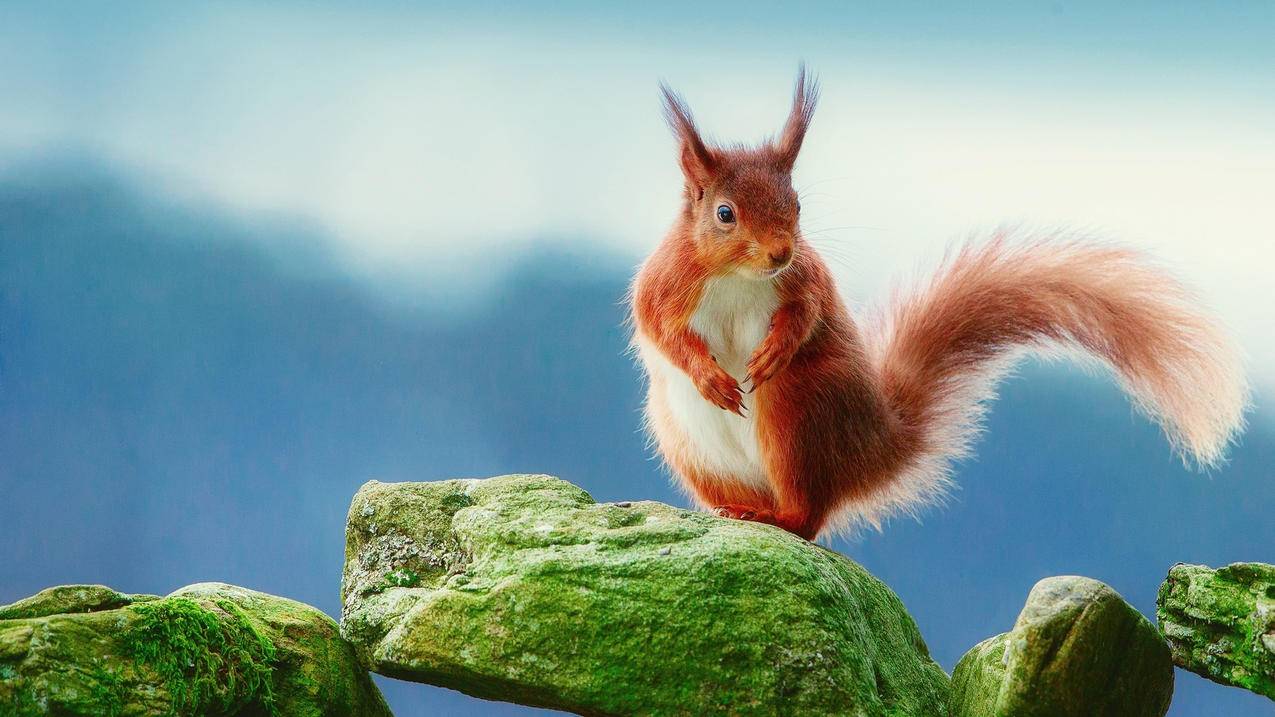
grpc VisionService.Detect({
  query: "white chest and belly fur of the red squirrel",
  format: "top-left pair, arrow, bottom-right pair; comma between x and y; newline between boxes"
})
639,277 -> 779,487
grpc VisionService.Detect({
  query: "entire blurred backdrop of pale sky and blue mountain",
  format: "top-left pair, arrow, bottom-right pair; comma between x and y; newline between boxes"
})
0,0 -> 1275,717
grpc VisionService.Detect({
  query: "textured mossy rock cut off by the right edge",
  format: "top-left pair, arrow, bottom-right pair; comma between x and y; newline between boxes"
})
1156,563 -> 1275,699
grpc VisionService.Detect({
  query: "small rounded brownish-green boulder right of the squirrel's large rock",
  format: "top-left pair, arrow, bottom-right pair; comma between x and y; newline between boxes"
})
951,577 -> 1173,717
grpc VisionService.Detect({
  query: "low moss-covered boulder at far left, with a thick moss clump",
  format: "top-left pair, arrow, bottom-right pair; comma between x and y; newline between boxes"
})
0,583 -> 390,717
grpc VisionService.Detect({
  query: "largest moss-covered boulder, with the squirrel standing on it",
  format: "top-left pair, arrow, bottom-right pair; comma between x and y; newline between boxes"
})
342,475 -> 947,717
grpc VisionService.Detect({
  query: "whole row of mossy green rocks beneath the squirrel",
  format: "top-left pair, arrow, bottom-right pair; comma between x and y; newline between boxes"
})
19,475 -> 1275,717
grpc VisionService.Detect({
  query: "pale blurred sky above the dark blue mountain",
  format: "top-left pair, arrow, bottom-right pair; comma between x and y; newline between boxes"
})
0,3 -> 1275,367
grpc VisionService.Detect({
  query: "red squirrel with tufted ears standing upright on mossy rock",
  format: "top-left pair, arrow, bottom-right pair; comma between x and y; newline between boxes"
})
630,69 -> 1248,540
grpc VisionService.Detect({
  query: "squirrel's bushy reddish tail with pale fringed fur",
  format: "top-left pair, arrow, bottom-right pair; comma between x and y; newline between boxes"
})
863,232 -> 1248,521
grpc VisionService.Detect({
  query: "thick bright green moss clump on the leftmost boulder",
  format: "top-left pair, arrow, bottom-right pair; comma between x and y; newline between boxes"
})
125,597 -> 278,716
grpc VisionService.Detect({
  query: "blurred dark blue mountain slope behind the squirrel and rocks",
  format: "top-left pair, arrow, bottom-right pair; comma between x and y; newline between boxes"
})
0,162 -> 1275,717
